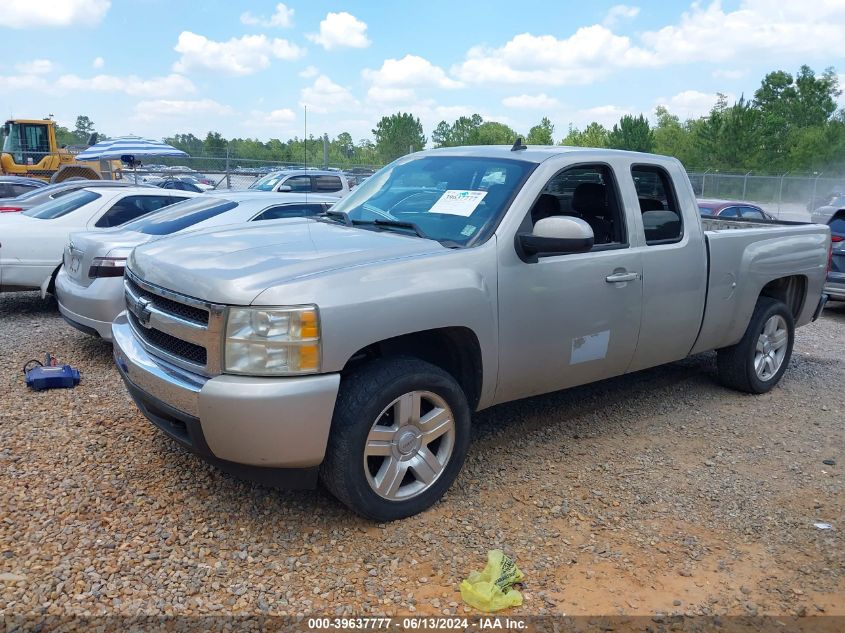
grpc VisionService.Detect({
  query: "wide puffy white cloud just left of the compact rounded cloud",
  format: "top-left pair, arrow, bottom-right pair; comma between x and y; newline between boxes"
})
173,31 -> 305,75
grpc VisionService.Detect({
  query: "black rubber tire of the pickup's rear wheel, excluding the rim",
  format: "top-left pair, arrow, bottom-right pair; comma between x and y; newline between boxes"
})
717,297 -> 795,393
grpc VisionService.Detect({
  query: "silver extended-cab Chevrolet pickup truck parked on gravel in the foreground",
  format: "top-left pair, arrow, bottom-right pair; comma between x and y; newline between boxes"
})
113,144 -> 830,521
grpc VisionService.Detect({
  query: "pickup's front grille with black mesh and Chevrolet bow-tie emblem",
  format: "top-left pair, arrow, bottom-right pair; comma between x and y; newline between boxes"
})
124,269 -> 225,376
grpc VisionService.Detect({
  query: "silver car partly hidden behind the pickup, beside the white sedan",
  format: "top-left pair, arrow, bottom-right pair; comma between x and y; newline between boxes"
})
56,191 -> 337,341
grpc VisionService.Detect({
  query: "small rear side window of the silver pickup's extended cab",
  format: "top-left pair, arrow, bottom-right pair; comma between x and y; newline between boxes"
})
631,165 -> 684,246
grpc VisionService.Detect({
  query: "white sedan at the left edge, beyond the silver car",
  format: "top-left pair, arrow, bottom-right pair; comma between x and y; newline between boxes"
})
0,185 -> 198,296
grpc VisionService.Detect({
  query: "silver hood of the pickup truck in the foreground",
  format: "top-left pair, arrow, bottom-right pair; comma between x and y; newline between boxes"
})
128,218 -> 446,305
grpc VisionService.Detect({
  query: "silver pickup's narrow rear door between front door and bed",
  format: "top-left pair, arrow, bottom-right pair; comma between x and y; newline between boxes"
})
625,163 -> 708,371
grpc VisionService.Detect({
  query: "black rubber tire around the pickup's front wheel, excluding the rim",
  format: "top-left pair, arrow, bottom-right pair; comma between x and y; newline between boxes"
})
320,357 -> 471,521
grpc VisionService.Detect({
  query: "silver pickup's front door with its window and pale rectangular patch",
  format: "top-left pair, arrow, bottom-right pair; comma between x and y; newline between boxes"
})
496,165 -> 642,402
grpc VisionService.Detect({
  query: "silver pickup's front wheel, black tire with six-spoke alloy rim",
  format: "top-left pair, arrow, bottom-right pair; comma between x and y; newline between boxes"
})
320,358 -> 470,521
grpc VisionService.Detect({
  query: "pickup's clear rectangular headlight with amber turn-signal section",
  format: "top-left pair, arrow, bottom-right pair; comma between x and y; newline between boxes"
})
225,306 -> 320,376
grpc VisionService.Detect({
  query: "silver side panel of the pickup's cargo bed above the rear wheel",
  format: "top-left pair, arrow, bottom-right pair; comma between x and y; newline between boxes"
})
690,224 -> 829,354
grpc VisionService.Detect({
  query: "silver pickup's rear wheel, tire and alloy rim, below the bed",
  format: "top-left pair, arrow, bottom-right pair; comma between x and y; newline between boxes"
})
717,297 -> 795,393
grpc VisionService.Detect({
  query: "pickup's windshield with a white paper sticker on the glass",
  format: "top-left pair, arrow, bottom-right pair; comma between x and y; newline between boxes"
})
330,155 -> 535,246
